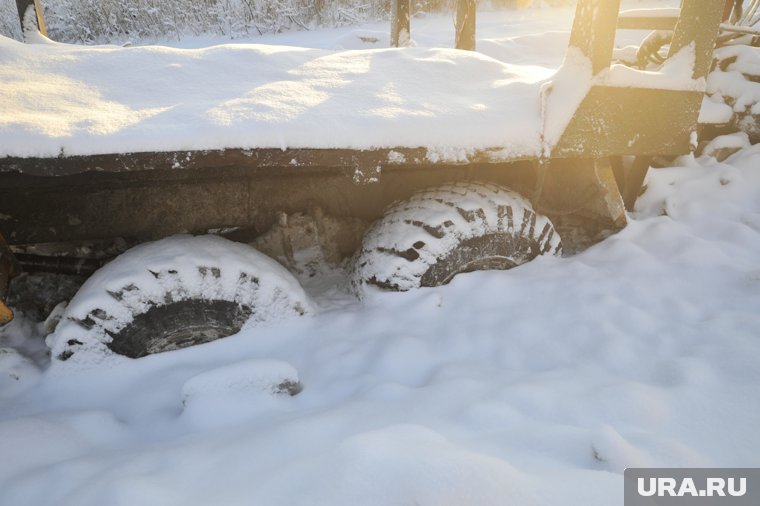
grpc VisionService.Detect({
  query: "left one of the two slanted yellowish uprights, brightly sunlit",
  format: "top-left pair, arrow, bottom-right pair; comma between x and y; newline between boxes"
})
570,0 -> 620,75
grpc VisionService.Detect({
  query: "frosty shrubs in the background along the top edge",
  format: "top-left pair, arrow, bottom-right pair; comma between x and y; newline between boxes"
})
0,0 -> 571,44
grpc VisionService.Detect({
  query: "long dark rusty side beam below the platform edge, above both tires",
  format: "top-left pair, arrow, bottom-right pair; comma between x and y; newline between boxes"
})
0,160 -> 535,245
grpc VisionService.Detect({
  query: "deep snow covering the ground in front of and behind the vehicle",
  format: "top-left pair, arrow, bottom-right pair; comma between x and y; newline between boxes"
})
5,2 -> 760,506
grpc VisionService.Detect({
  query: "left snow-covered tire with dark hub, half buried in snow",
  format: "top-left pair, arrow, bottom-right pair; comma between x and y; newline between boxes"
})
47,236 -> 312,361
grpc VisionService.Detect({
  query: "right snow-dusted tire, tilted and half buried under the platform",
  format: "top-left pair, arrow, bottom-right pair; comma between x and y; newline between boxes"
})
351,182 -> 562,295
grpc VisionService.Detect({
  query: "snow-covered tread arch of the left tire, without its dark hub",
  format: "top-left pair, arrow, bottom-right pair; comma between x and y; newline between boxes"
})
47,235 -> 313,363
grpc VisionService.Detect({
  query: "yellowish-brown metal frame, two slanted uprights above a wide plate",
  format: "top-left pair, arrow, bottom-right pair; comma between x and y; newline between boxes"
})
552,0 -> 724,158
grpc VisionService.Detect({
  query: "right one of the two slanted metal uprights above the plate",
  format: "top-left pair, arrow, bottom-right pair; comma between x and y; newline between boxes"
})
668,0 -> 725,79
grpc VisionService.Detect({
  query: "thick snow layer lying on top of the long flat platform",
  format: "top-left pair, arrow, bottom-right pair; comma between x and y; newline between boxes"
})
0,37 -> 549,158
